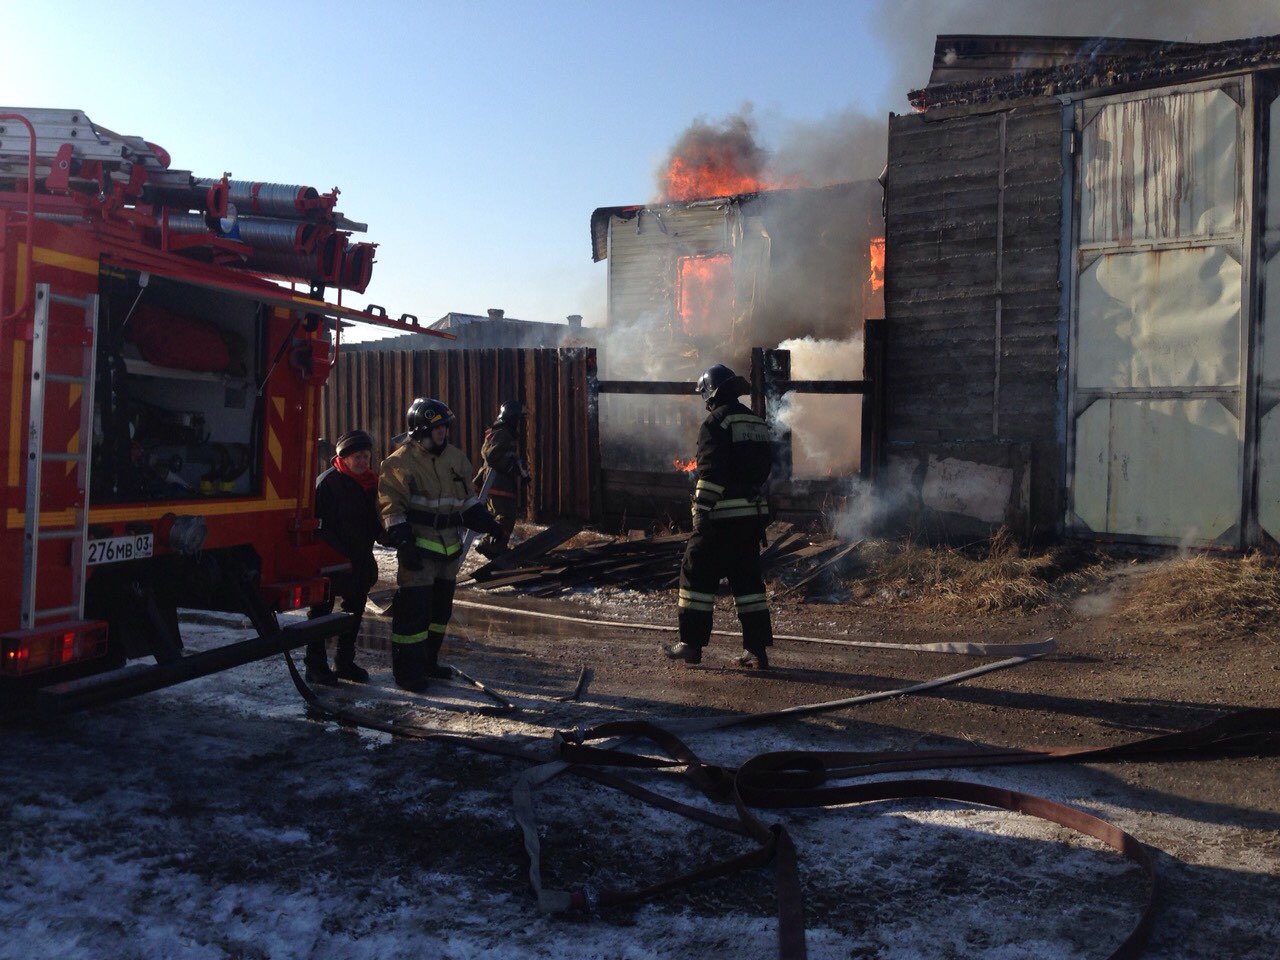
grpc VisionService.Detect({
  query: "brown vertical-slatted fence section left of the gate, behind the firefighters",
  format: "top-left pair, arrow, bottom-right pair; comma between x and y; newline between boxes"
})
320,348 -> 599,521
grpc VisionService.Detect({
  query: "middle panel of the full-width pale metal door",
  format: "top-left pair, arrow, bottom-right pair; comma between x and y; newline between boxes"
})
1076,247 -> 1240,388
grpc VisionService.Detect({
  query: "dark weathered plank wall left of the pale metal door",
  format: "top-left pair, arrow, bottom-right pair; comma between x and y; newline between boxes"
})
884,101 -> 1062,532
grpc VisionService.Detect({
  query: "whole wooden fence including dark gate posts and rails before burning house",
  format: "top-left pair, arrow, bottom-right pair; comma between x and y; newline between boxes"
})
317,335 -> 883,529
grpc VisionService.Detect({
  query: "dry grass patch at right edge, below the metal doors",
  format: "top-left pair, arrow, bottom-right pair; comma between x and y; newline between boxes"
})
1124,553 -> 1280,631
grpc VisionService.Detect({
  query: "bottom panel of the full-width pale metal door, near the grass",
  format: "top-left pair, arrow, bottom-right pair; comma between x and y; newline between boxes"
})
1075,399 -> 1240,543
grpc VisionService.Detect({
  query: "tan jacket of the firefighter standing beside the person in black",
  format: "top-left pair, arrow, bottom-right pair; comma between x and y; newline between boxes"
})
378,440 -> 480,559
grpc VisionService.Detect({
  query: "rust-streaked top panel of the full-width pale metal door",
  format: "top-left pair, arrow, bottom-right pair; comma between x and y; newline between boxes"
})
1080,90 -> 1242,243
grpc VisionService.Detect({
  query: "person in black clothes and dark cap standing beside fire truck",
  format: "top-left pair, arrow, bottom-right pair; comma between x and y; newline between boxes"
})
303,430 -> 383,686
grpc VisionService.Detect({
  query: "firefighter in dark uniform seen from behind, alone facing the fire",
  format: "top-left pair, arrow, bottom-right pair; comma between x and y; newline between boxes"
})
662,364 -> 773,669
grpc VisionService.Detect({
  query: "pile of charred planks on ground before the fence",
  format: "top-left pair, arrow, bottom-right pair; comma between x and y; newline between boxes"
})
463,521 -> 861,596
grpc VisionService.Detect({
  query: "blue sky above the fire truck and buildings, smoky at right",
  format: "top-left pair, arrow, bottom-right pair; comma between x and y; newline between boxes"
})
0,0 -> 1280,337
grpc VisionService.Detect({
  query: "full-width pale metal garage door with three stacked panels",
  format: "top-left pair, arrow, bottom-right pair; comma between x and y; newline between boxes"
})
1066,79 -> 1249,545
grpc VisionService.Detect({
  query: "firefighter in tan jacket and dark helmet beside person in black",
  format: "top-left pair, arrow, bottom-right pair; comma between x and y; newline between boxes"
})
378,397 -> 502,692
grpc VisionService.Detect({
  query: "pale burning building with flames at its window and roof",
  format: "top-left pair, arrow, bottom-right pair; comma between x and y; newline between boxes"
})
591,176 -> 883,478
